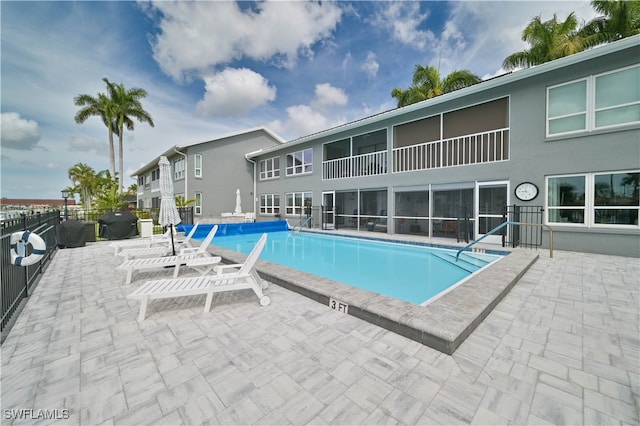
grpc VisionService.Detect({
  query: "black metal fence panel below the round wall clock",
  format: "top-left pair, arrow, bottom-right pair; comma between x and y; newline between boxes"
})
502,204 -> 544,248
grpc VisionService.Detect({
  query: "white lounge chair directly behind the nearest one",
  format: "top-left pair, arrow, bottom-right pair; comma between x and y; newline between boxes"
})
116,225 -> 221,284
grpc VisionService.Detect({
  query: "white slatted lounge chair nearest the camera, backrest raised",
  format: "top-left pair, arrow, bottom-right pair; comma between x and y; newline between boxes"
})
128,234 -> 271,321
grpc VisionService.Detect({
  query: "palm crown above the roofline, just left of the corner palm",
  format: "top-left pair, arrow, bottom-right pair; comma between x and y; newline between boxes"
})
502,13 -> 588,69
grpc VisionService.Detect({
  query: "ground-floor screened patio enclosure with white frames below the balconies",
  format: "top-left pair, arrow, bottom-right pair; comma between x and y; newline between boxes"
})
323,181 -> 509,243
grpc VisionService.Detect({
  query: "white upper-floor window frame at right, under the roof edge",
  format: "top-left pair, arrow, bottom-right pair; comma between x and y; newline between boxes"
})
545,65 -> 640,138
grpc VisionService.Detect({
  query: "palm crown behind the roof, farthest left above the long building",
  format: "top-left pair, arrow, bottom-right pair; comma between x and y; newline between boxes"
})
391,65 -> 480,108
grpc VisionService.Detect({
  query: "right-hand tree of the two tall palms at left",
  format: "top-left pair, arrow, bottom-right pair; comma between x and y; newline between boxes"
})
102,77 -> 154,192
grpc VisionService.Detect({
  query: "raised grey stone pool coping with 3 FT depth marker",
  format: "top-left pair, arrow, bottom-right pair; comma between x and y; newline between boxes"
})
209,235 -> 539,355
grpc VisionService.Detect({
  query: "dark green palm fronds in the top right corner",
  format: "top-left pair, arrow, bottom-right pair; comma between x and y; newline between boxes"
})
580,0 -> 640,46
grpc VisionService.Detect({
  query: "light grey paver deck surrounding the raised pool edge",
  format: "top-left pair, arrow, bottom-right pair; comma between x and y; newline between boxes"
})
1,235 -> 640,425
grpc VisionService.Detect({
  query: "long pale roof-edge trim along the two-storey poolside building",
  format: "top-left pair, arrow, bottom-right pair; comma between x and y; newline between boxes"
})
248,35 -> 640,157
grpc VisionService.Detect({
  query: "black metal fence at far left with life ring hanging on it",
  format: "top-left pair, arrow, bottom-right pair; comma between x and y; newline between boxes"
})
0,210 -> 60,341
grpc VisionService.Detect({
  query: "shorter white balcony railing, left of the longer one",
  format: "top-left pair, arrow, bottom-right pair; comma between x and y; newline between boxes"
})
322,151 -> 387,180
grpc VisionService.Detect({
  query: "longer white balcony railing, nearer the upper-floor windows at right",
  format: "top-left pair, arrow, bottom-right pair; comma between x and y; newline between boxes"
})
393,128 -> 509,172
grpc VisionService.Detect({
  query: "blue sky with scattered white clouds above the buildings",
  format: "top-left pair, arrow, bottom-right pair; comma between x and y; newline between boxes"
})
0,1 -> 595,198
